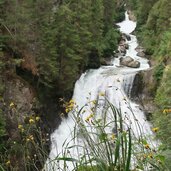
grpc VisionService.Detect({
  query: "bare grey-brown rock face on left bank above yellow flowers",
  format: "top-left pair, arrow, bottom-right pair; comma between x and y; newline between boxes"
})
4,77 -> 35,139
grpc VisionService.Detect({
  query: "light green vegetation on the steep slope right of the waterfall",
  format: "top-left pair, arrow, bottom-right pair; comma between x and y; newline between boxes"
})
128,0 -> 171,168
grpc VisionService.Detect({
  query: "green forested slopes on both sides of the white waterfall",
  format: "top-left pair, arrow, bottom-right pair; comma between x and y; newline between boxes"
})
0,0 -> 171,171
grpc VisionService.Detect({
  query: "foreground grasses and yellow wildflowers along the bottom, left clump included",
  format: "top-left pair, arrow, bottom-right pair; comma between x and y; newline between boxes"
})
0,97 -> 168,171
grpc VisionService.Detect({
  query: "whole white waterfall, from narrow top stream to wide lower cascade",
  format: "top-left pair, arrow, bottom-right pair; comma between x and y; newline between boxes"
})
44,12 -> 158,171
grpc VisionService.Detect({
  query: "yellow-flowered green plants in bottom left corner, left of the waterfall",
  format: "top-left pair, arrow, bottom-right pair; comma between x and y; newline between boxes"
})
0,103 -> 49,171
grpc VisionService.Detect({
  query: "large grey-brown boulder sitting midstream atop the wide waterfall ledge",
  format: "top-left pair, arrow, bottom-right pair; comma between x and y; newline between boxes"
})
120,56 -> 140,68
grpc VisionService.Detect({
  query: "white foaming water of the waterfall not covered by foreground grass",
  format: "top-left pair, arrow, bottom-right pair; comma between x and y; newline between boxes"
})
45,13 -> 155,171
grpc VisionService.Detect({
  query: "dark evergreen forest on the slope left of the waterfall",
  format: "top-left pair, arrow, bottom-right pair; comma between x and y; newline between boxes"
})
0,0 -> 124,169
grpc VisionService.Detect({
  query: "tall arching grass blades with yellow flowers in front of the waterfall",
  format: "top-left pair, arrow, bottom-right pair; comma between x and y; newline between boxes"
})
52,97 -> 167,171
